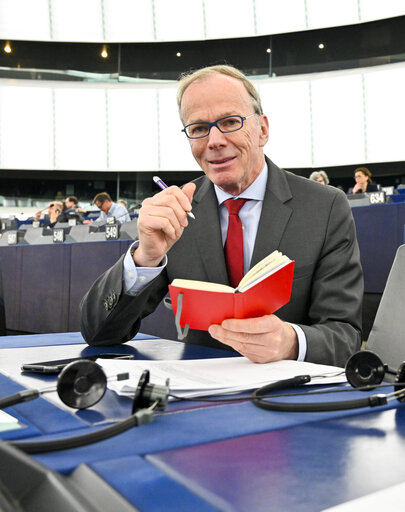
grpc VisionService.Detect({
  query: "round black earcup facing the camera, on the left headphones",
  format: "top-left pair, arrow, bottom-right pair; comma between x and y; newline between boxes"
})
56,359 -> 107,409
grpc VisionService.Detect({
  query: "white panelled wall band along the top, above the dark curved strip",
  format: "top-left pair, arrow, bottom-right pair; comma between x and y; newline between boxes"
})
0,0 -> 405,42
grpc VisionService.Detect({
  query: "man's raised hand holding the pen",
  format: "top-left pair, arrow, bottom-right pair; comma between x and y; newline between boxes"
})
134,183 -> 195,267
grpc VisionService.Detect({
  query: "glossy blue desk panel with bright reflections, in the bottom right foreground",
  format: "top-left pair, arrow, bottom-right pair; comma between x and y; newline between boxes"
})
146,407 -> 405,512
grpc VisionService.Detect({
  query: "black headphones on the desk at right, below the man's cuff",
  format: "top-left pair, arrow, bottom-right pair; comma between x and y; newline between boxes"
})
252,350 -> 405,412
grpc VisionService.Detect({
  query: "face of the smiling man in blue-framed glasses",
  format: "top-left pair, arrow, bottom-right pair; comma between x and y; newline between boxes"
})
181,74 -> 268,195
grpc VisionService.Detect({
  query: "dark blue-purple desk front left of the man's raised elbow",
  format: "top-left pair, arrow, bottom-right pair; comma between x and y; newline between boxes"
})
0,240 -> 131,333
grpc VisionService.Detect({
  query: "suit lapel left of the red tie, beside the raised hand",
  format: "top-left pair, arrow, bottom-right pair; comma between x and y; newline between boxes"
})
191,178 -> 229,284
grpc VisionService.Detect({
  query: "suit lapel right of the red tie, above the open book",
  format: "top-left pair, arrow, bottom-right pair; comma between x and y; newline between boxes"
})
250,157 -> 292,267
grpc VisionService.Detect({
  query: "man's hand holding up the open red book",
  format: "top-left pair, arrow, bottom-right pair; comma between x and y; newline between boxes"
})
208,315 -> 298,363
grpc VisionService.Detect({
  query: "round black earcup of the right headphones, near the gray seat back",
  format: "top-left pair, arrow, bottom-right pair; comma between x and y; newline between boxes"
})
345,350 -> 385,388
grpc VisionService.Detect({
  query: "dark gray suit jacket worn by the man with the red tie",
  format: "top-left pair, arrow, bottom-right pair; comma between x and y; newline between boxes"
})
81,159 -> 363,366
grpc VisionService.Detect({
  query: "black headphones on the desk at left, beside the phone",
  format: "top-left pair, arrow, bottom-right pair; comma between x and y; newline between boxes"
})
0,359 -> 169,453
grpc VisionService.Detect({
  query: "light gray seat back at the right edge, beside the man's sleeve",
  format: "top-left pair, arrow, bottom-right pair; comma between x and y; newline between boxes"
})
366,245 -> 405,380
